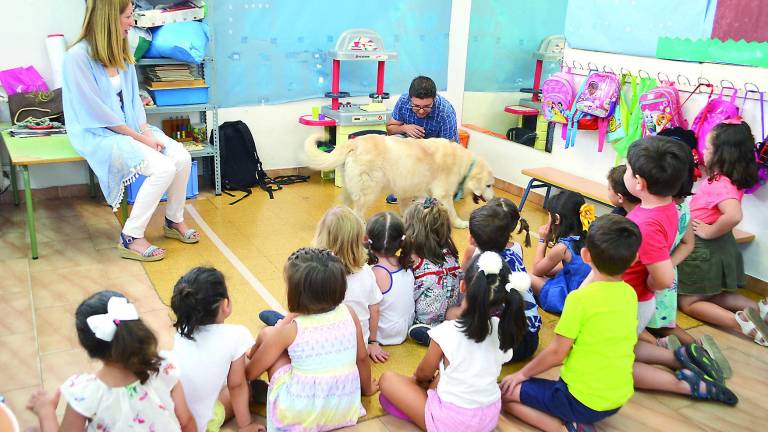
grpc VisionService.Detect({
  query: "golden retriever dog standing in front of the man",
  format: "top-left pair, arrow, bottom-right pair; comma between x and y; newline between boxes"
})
304,134 -> 494,228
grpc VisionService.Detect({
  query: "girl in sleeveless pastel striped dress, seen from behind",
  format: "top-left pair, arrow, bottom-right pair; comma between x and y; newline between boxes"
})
246,248 -> 378,431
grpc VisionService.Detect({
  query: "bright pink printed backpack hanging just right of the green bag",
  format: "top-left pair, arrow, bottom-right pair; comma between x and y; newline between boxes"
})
639,82 -> 688,136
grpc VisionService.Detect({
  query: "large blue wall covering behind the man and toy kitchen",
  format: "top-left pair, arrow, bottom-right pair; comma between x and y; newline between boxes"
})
210,0 -> 451,107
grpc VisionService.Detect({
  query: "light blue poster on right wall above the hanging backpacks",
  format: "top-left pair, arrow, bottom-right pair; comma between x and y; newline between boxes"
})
565,0 -> 717,57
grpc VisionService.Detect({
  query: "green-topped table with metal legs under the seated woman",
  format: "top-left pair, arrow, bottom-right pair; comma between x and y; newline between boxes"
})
0,124 -> 96,259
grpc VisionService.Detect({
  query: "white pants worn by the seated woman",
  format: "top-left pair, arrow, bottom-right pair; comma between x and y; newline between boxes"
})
123,131 -> 192,238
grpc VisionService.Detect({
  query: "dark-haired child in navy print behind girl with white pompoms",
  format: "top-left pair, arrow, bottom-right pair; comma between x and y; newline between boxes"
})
462,198 -> 541,361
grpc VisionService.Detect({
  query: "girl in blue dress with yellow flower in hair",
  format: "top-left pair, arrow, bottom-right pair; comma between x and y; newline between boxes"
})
531,190 -> 595,314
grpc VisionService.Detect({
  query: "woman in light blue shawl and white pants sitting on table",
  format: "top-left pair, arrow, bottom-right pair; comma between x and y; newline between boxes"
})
63,0 -> 199,261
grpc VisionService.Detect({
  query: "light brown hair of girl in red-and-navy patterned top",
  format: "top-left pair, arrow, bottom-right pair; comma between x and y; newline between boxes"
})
402,198 -> 459,265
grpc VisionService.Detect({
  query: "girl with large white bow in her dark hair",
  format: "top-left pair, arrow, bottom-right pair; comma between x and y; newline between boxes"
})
27,291 -> 197,432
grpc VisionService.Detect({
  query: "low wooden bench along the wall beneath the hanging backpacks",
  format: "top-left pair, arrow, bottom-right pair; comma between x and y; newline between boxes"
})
520,167 -> 755,243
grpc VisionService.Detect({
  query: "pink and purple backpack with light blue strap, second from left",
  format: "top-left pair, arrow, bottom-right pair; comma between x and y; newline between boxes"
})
565,71 -> 620,151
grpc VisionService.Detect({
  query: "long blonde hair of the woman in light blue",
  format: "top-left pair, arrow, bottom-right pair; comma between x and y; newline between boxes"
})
75,0 -> 134,69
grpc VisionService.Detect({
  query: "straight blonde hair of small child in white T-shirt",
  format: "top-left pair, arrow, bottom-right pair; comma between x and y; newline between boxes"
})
312,206 -> 368,274
